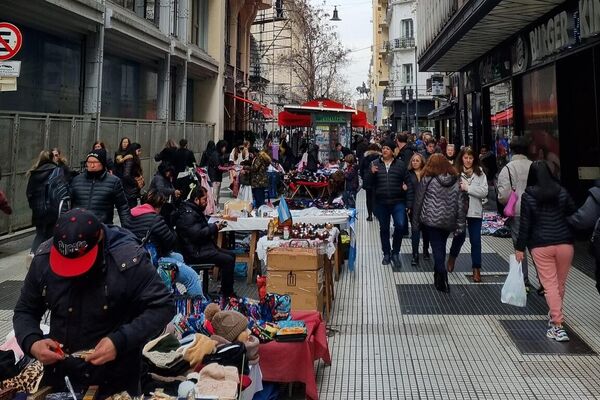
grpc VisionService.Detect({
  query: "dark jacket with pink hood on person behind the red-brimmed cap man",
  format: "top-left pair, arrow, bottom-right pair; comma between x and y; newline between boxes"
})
125,204 -> 177,258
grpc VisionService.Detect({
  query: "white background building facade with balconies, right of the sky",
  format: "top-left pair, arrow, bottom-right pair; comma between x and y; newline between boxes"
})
384,0 -> 434,132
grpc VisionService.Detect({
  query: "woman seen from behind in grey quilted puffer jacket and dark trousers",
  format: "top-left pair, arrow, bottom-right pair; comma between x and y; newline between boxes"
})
412,153 -> 466,292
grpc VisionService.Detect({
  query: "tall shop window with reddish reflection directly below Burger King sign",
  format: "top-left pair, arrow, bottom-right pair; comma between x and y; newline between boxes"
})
522,65 -> 560,176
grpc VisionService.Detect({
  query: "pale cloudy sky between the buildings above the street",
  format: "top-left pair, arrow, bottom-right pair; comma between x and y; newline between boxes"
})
311,0 -> 373,103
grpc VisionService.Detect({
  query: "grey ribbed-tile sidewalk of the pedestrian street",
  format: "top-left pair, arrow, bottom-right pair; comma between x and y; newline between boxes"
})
0,194 -> 600,399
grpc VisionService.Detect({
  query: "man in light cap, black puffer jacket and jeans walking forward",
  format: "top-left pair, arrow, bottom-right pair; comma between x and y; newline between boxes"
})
367,140 -> 414,268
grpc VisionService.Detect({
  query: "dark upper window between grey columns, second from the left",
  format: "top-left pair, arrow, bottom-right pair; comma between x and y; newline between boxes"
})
102,54 -> 158,119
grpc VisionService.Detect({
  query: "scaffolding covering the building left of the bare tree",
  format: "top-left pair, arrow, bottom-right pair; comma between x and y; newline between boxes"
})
250,0 -> 299,131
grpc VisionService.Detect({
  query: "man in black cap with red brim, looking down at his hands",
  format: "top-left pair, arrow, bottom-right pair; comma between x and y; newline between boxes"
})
13,209 -> 175,395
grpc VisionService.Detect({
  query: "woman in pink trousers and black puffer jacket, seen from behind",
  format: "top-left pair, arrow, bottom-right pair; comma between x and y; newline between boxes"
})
515,161 -> 576,342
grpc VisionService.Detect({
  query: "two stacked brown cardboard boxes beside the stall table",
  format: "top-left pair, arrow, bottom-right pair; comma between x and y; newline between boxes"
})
267,247 -> 325,311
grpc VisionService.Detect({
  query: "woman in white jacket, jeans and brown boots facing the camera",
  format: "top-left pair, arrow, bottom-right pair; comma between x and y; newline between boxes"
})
448,147 -> 488,282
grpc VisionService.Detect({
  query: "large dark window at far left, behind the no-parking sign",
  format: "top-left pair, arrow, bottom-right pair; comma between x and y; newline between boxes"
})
0,26 -> 82,114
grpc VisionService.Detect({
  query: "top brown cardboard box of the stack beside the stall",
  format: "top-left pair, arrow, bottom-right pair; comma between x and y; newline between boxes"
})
267,247 -> 325,271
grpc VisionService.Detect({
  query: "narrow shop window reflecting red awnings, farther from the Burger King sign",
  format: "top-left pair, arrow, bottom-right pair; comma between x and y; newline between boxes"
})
489,81 -> 514,168
